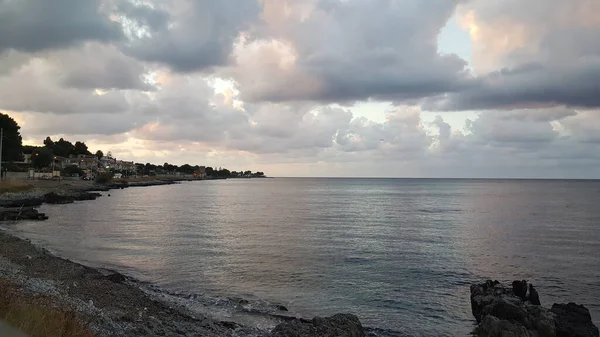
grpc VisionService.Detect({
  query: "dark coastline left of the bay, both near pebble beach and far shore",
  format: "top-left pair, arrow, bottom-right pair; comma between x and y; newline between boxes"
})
0,179 -> 364,337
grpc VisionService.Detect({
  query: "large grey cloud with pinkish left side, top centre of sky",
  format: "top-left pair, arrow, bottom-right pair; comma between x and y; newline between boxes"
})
231,0 -> 466,102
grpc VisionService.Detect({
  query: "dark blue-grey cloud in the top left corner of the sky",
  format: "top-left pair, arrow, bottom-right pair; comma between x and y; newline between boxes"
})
0,0 -> 123,53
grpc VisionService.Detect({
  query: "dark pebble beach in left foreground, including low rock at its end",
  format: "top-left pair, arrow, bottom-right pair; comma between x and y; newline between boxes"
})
0,231 -> 365,337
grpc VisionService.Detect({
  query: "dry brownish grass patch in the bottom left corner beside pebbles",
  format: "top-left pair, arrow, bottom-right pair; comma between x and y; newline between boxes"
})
0,280 -> 94,337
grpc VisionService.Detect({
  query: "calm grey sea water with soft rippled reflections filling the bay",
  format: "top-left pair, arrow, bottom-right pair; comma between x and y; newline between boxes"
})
5,179 -> 600,336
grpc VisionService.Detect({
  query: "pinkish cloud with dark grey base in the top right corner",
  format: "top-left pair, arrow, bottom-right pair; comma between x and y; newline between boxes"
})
434,0 -> 600,110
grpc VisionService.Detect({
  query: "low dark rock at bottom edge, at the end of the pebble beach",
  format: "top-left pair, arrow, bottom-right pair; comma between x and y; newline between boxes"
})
270,314 -> 365,337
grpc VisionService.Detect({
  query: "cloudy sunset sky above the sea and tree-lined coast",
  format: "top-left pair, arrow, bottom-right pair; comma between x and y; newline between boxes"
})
0,0 -> 600,178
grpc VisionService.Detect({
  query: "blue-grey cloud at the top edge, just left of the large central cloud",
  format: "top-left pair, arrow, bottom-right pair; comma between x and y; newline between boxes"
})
123,0 -> 260,72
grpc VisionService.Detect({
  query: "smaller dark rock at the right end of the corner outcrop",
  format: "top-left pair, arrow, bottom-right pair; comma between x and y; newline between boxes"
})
550,303 -> 598,337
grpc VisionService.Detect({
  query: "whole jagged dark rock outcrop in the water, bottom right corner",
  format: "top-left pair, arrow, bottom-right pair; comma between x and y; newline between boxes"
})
471,280 -> 598,337
